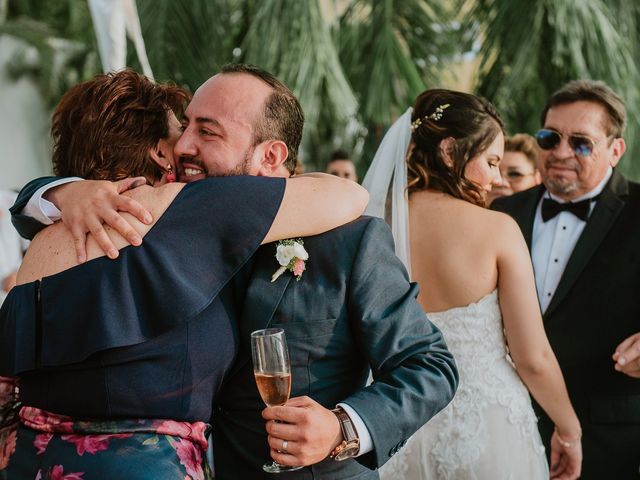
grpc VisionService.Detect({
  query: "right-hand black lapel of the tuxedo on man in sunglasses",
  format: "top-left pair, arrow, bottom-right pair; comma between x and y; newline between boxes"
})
544,171 -> 628,317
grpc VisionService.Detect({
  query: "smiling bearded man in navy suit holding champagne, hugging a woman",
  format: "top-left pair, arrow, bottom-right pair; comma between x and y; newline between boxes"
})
14,65 -> 457,479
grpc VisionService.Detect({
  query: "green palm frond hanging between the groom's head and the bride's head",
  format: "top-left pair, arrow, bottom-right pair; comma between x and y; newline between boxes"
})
335,0 -> 451,173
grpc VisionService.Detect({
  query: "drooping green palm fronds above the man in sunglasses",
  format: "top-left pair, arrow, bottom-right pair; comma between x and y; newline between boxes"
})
467,0 -> 640,178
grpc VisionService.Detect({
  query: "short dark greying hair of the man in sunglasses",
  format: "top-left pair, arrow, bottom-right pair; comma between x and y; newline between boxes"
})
541,80 -> 627,138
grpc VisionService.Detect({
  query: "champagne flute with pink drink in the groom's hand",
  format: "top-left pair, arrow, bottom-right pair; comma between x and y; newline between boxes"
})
251,328 -> 302,473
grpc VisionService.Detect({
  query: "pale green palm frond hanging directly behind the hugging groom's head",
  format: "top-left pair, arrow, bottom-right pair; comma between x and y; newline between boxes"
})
242,0 -> 357,169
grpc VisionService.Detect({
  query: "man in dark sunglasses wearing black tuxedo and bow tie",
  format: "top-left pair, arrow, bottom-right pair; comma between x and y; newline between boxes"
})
492,81 -> 640,480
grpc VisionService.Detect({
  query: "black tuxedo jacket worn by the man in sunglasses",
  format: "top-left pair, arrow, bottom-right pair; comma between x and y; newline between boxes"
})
491,171 -> 640,479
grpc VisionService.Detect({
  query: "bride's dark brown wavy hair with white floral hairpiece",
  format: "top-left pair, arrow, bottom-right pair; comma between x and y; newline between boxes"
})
407,89 -> 504,206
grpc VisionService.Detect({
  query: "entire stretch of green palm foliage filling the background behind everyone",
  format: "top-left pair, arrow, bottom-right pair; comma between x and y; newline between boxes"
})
0,0 -> 640,179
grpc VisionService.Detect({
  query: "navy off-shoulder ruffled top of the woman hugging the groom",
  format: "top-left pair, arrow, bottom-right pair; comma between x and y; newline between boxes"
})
0,177 -> 285,421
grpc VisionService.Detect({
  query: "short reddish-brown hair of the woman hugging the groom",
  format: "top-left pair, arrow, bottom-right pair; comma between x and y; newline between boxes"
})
51,70 -> 190,183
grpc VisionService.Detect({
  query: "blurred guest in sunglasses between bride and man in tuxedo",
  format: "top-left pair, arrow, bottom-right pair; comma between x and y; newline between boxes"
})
487,133 -> 542,203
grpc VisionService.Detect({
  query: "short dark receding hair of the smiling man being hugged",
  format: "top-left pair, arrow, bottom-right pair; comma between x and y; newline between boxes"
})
220,63 -> 304,174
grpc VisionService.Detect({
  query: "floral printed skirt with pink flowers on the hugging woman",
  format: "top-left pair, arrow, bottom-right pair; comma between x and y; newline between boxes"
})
0,407 -> 212,480
